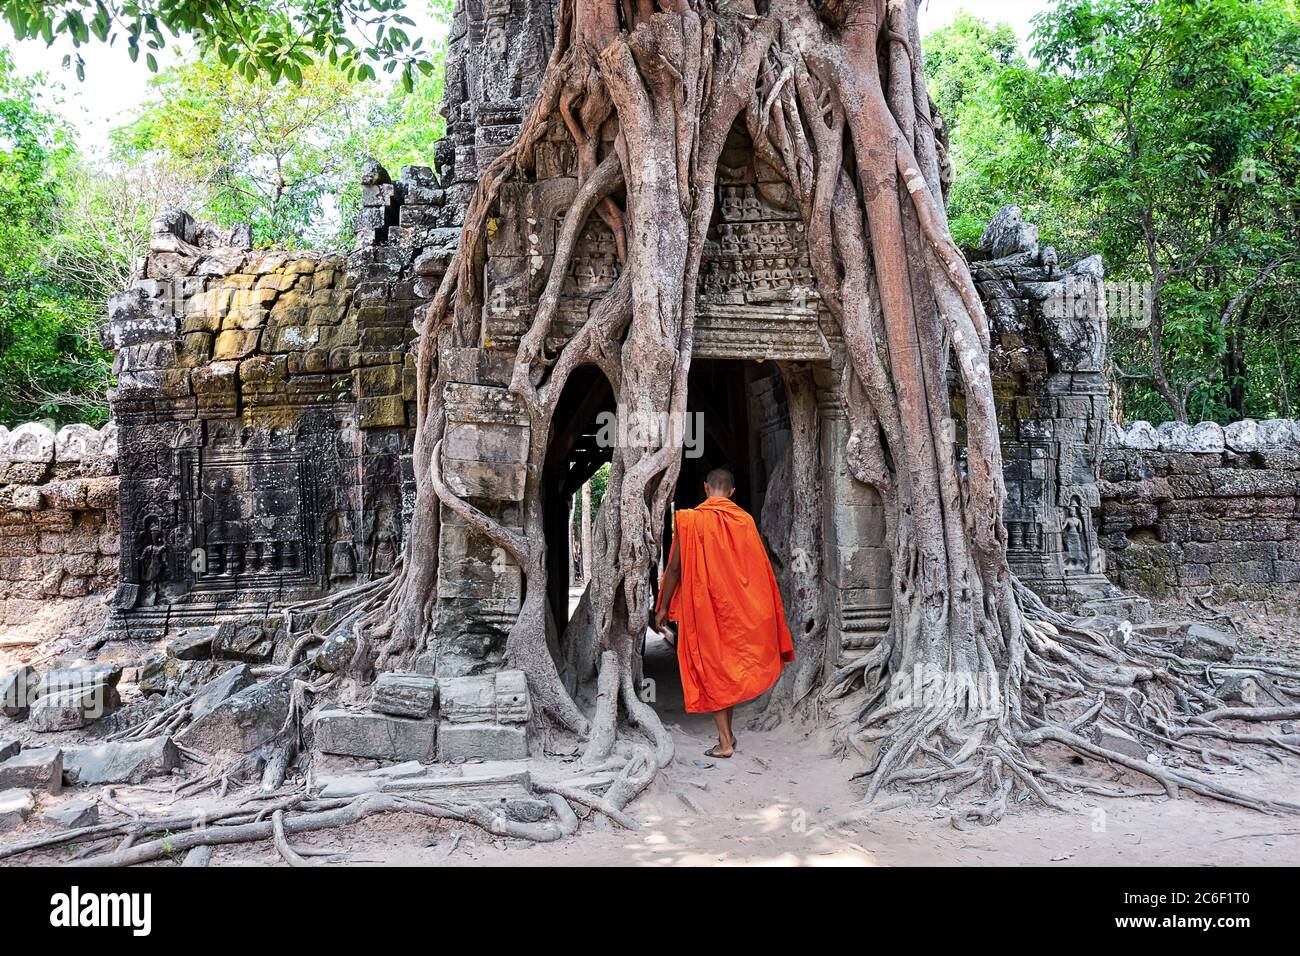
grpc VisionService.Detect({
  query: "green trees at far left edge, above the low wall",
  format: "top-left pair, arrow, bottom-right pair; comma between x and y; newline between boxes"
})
0,49 -> 108,424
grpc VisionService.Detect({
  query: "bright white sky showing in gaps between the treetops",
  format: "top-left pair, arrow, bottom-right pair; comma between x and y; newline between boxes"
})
0,0 -> 1050,152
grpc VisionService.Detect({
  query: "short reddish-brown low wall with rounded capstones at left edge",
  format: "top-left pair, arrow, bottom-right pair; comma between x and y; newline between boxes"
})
0,423 -> 118,624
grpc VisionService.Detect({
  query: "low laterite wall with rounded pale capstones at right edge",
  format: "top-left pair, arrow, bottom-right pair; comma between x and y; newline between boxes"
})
1100,419 -> 1300,594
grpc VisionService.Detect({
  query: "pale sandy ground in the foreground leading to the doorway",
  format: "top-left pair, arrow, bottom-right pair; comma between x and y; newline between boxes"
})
0,590 -> 1300,866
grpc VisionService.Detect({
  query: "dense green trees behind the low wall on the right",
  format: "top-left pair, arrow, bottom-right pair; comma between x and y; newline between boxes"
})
926,0 -> 1300,421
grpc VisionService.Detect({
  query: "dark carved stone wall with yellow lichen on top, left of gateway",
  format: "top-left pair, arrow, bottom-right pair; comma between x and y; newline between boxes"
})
103,205 -> 455,637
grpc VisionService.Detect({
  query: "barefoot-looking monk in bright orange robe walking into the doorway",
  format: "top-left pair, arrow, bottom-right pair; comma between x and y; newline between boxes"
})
654,468 -> 794,757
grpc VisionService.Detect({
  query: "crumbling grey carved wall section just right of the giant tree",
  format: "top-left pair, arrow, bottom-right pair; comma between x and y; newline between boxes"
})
977,206 -> 1119,610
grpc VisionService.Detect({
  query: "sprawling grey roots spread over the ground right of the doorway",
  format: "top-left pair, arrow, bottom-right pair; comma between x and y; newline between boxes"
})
823,594 -> 1300,829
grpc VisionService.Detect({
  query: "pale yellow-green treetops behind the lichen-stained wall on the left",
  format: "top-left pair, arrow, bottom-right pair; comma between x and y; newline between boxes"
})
113,0 -> 451,248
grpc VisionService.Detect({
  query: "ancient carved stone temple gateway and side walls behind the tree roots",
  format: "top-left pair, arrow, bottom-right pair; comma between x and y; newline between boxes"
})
98,0 -> 1115,702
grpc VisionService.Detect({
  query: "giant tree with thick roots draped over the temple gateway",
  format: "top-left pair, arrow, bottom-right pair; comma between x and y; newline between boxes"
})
10,0 -> 1300,822
